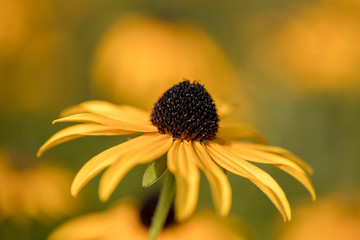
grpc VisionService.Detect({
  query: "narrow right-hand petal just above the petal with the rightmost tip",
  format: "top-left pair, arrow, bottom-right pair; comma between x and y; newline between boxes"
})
236,142 -> 314,174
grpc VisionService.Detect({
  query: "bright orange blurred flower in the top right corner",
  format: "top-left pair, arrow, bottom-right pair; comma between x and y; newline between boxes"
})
255,0 -> 360,92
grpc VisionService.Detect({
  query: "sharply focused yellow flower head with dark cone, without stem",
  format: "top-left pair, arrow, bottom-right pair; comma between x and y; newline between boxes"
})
38,81 -> 315,220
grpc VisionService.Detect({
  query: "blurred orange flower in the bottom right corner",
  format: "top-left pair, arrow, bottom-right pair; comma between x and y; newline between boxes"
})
278,194 -> 360,240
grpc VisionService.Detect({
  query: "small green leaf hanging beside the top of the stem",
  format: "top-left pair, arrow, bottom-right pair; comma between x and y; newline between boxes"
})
142,156 -> 167,187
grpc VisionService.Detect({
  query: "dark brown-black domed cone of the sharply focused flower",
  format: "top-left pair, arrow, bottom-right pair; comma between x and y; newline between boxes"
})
151,80 -> 219,141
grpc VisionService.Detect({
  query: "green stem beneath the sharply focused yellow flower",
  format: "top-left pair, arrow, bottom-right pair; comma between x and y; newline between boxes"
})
149,172 -> 175,240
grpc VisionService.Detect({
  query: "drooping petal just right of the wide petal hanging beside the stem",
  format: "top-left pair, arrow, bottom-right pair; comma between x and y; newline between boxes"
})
193,141 -> 231,216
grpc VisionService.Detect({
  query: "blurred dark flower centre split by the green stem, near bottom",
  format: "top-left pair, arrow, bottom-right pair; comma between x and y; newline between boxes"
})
140,194 -> 175,228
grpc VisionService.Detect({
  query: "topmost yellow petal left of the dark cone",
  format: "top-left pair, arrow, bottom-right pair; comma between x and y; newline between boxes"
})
61,100 -> 149,123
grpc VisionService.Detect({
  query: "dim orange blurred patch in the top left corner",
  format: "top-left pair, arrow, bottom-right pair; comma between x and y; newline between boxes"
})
0,0 -> 78,112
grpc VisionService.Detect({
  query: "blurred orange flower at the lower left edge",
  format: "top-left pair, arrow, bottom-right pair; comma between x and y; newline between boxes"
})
0,149 -> 75,223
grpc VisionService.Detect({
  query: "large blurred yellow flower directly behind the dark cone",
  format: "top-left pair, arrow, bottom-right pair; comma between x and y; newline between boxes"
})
93,14 -> 248,119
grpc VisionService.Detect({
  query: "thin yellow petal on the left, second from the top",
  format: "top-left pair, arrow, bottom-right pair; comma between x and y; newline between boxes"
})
53,113 -> 158,132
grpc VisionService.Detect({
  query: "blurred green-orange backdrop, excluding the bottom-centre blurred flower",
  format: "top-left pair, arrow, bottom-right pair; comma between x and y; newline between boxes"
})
0,0 -> 360,240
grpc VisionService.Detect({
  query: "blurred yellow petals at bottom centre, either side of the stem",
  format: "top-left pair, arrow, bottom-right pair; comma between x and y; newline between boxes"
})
48,200 -> 250,240
